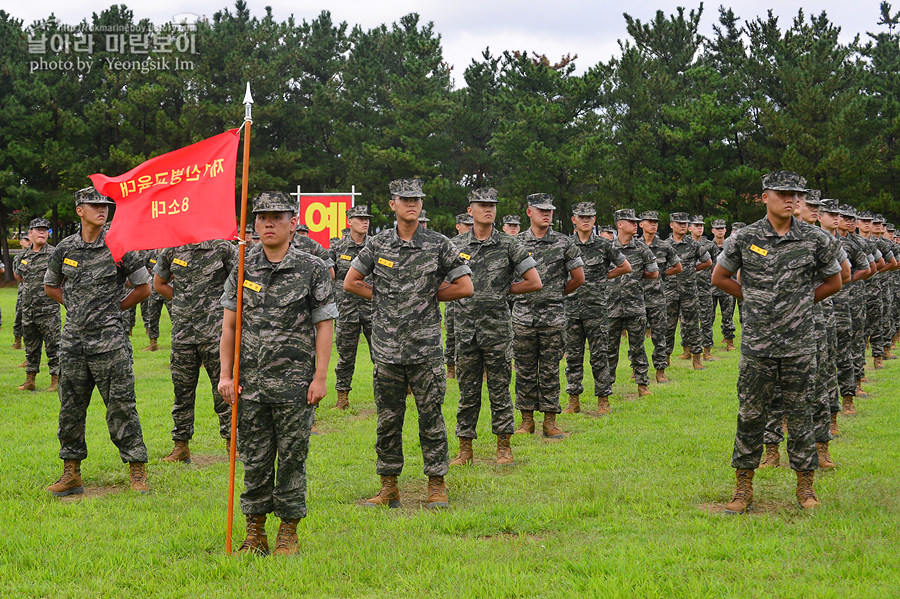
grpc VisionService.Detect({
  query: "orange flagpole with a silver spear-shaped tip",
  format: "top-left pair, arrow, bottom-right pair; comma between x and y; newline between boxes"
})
225,81 -> 253,555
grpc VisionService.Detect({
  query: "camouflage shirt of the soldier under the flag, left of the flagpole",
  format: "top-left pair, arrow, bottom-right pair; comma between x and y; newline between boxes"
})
153,239 -> 238,345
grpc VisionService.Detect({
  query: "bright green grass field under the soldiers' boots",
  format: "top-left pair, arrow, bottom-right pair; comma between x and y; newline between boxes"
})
0,288 -> 900,599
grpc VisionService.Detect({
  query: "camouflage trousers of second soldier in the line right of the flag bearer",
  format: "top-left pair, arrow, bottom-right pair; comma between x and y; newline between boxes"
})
456,339 -> 515,439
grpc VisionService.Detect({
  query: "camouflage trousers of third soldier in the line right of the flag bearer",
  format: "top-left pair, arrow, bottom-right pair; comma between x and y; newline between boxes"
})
513,323 -> 566,414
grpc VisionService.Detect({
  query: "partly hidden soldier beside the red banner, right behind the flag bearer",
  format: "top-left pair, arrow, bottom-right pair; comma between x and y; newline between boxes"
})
330,206 -> 372,410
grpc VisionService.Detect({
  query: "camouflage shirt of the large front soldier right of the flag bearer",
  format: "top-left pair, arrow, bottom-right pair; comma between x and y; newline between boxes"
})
350,227 -> 472,364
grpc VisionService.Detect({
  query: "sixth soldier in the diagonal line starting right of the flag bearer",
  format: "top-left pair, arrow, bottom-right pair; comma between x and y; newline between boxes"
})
640,210 -> 683,384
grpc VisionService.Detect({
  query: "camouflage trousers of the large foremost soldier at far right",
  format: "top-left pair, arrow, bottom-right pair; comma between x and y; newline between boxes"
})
731,354 -> 819,472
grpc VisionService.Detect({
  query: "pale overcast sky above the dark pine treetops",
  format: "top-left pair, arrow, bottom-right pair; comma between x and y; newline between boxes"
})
8,0 -> 900,85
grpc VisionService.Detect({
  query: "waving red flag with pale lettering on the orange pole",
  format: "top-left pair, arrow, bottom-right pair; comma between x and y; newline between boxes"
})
90,129 -> 240,262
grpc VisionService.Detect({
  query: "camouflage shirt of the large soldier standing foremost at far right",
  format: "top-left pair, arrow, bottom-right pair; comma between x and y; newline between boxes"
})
718,217 -> 841,358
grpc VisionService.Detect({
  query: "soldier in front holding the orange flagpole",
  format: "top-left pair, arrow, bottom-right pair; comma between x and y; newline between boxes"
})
219,192 -> 337,556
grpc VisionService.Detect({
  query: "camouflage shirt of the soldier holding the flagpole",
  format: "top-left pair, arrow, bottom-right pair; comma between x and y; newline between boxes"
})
221,248 -> 337,403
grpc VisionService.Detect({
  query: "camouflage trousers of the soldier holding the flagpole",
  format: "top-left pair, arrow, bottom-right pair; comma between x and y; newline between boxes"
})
237,400 -> 315,519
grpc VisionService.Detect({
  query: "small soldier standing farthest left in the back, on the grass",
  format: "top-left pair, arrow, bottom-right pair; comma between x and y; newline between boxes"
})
14,218 -> 61,391
